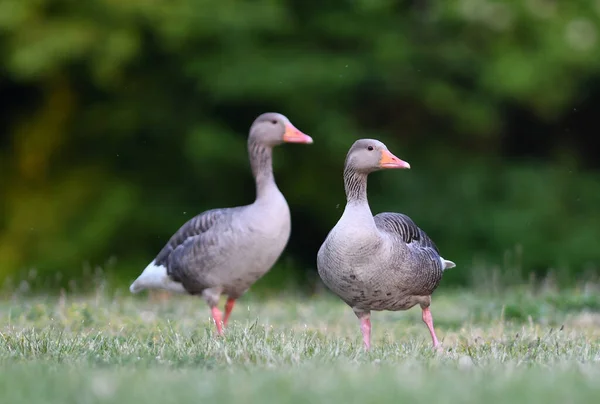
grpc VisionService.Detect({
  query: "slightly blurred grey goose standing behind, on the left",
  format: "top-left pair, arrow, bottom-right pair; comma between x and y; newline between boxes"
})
129,113 -> 312,335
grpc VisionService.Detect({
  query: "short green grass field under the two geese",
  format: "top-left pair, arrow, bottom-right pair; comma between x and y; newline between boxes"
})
0,290 -> 600,404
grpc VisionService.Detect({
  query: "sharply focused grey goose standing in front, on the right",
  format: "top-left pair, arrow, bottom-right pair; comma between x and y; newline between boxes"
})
317,139 -> 455,350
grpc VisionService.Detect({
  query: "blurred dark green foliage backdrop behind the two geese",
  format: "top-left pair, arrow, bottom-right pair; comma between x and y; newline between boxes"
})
0,0 -> 600,288
